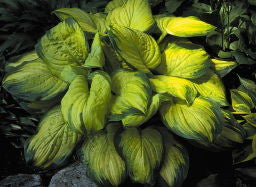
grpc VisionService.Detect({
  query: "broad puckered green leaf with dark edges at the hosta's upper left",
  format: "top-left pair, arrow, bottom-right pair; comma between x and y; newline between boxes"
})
36,18 -> 88,75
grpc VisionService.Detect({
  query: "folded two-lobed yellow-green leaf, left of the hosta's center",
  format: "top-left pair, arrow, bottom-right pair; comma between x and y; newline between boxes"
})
61,71 -> 111,134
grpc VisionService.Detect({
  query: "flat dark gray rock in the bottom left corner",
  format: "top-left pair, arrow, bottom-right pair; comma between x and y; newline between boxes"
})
0,174 -> 43,187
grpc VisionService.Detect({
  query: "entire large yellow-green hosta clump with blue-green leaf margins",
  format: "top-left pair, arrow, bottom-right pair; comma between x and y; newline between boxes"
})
3,0 -> 236,186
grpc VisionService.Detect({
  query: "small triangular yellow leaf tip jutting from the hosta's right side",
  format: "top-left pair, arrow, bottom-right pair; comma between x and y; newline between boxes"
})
211,59 -> 237,77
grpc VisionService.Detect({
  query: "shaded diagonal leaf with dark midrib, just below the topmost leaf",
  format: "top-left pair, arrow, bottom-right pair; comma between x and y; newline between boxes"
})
110,25 -> 161,73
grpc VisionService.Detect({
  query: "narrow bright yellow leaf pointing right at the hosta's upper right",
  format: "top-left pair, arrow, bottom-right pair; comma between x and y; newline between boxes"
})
157,16 -> 216,37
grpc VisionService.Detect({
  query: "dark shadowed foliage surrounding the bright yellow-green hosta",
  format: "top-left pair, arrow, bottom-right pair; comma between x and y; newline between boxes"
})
0,0 -> 256,187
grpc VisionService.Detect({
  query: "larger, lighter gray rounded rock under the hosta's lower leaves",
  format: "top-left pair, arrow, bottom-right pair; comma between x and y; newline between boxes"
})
49,162 -> 97,187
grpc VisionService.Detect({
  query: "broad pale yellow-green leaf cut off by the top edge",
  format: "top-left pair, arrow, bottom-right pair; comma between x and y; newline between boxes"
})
107,0 -> 154,31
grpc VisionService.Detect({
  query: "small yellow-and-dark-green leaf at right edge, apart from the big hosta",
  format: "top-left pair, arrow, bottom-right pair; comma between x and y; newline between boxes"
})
230,89 -> 255,114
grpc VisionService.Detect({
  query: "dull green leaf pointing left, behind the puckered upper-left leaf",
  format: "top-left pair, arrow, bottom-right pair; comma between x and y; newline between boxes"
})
53,8 -> 107,34
